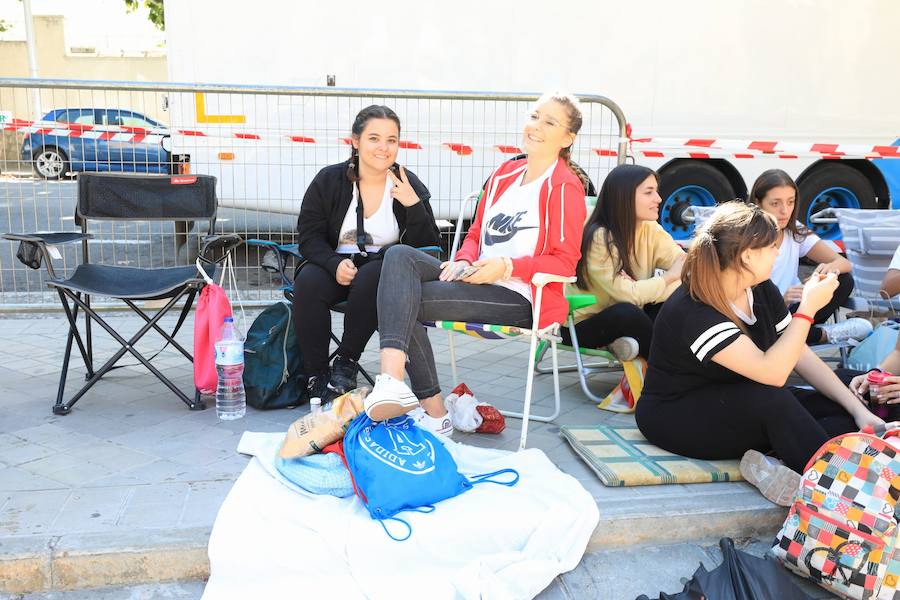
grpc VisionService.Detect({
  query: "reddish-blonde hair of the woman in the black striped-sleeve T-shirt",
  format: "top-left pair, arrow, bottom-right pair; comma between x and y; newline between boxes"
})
681,201 -> 778,333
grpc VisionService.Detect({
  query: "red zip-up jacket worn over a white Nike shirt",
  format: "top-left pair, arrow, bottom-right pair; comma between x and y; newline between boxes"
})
456,159 -> 587,327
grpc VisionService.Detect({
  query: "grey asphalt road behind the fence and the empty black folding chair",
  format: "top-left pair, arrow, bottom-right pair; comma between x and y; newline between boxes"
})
0,177 -> 297,299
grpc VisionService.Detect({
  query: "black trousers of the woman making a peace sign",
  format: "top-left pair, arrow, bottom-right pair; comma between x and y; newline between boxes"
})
293,257 -> 384,375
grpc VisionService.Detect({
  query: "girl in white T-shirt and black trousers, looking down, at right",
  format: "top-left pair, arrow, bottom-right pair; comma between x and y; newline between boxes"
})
750,169 -> 872,344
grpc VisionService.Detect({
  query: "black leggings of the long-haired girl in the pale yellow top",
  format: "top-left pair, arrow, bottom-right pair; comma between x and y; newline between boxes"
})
561,302 -> 662,358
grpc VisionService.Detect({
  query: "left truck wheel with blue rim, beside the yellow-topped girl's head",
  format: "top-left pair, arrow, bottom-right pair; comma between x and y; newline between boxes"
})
659,161 -> 734,240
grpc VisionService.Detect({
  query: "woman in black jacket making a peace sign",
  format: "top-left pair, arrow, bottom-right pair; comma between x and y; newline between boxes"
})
294,105 -> 440,403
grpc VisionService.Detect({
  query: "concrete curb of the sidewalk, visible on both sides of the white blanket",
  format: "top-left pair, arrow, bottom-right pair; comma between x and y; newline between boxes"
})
0,496 -> 786,593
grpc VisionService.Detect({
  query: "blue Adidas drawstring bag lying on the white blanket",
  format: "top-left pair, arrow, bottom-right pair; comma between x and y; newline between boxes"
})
344,413 -> 519,542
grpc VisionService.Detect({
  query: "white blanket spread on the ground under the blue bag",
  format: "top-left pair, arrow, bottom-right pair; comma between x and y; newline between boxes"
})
203,432 -> 599,600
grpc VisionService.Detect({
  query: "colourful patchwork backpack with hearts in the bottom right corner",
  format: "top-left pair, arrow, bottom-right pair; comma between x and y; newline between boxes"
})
771,428 -> 900,600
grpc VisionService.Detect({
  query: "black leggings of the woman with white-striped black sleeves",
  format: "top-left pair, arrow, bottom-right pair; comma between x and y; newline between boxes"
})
635,369 -> 859,473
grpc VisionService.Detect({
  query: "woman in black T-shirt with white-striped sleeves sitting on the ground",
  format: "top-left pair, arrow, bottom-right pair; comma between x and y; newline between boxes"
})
635,202 -> 883,506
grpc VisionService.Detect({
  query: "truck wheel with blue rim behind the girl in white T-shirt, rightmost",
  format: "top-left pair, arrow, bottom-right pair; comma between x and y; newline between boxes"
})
797,164 -> 877,240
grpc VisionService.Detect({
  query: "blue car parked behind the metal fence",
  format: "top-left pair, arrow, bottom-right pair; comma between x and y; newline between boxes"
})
22,108 -> 171,179
